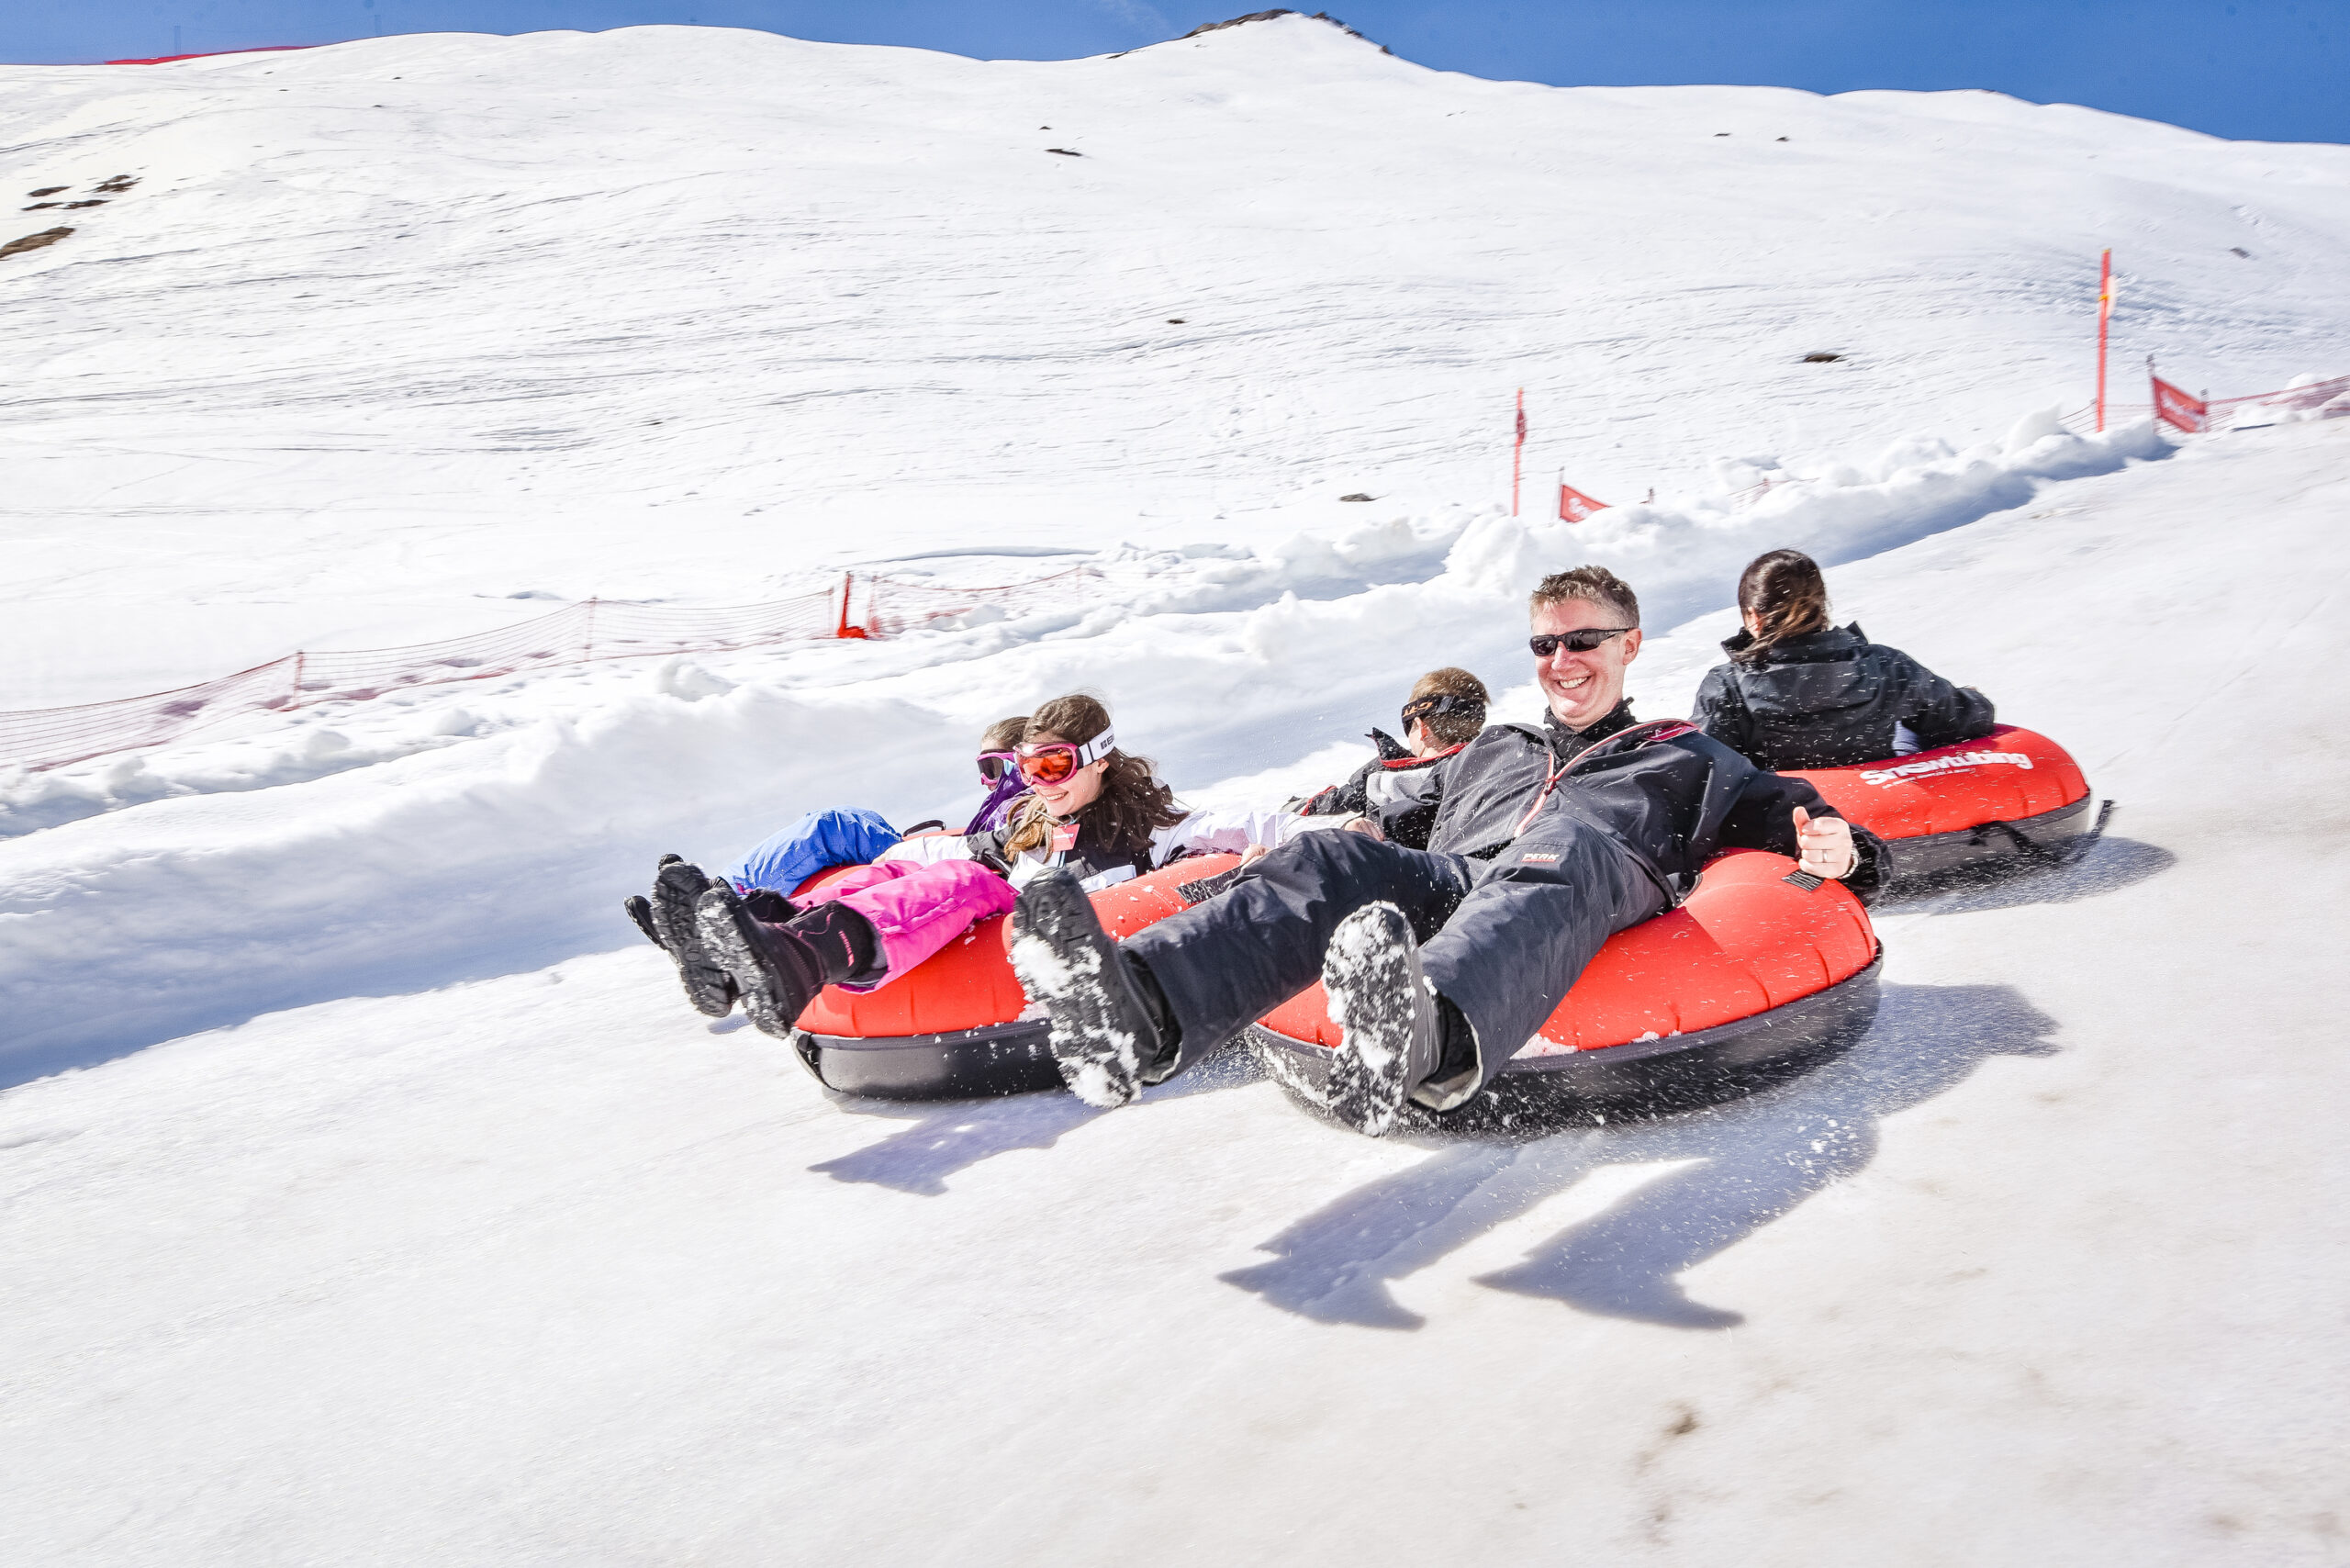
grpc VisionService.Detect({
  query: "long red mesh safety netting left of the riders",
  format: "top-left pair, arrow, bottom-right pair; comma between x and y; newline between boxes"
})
0,566 -> 1080,771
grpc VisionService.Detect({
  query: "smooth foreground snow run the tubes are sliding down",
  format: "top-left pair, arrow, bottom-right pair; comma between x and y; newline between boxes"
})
14,423 -> 2350,1568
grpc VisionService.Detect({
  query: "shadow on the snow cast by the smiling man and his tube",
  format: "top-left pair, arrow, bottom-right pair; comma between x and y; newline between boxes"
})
1222,985 -> 2056,1328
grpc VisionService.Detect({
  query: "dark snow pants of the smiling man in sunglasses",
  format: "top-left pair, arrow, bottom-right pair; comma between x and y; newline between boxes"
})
1125,811 -> 1671,1100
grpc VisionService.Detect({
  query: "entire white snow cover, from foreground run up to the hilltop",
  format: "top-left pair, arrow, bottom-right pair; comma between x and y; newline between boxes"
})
0,18 -> 2350,1568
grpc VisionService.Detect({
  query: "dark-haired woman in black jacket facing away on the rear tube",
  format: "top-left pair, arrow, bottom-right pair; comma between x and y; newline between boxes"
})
1692,550 -> 1995,771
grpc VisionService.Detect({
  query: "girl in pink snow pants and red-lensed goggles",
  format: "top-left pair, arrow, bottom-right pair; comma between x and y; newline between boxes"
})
696,693 -> 1370,1036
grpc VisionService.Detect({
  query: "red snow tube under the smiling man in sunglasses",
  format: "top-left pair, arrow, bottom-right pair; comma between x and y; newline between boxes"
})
1248,848 -> 1877,1121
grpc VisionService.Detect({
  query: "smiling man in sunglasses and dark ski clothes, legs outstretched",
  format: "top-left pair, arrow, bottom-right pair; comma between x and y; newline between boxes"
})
1013,566 -> 1880,1136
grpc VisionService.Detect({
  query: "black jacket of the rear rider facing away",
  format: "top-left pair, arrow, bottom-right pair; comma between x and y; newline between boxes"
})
1690,623 -> 1993,768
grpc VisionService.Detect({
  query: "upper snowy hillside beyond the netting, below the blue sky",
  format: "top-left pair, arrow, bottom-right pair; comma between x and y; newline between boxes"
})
0,18 -> 2350,708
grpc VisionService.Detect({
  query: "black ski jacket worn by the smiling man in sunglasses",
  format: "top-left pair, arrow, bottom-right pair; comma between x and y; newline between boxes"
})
1380,703 -> 1885,902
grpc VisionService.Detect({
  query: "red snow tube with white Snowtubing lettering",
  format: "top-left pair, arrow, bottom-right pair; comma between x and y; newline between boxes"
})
1788,724 -> 2110,884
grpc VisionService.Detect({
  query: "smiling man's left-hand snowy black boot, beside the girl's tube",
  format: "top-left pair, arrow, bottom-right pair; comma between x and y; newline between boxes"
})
1013,869 -> 1166,1110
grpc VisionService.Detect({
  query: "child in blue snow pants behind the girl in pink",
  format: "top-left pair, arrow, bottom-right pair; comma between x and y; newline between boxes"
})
622,714 -> 1027,1018
